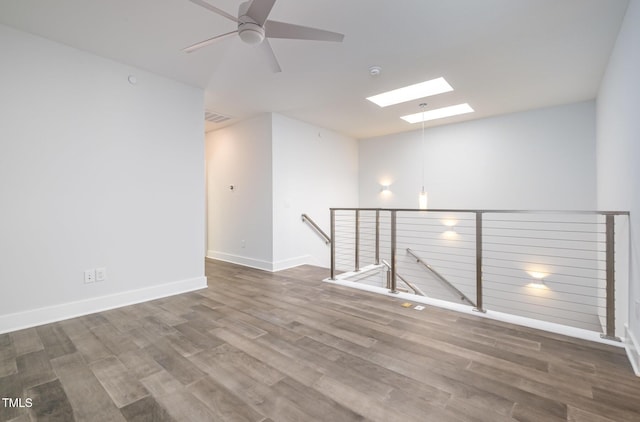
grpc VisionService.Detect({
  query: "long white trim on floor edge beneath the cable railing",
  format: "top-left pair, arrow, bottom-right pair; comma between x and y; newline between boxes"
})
323,273 -> 624,350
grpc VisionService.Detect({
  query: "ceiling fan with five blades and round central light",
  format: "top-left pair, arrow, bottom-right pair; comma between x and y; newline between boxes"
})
183,0 -> 344,72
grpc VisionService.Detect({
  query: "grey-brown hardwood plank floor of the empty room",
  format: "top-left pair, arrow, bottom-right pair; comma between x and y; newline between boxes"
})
0,260 -> 640,422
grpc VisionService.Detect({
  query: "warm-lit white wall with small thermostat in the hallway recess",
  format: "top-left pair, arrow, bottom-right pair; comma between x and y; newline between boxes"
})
206,114 -> 273,269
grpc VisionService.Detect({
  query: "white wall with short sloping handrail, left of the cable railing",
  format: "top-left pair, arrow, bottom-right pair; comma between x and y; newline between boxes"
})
273,114 -> 358,269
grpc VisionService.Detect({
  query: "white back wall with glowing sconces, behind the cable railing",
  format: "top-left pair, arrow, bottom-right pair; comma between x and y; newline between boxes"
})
360,101 -> 608,331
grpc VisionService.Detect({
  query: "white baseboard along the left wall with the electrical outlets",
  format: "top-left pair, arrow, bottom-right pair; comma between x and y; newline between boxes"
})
0,276 -> 207,334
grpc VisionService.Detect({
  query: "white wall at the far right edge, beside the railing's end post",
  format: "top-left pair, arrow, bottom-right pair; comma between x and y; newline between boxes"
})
597,0 -> 640,369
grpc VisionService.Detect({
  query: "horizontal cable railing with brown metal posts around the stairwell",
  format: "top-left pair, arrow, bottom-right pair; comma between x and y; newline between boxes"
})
331,208 -> 629,339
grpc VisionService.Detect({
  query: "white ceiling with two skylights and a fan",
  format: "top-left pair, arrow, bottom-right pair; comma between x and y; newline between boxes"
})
0,0 -> 628,138
